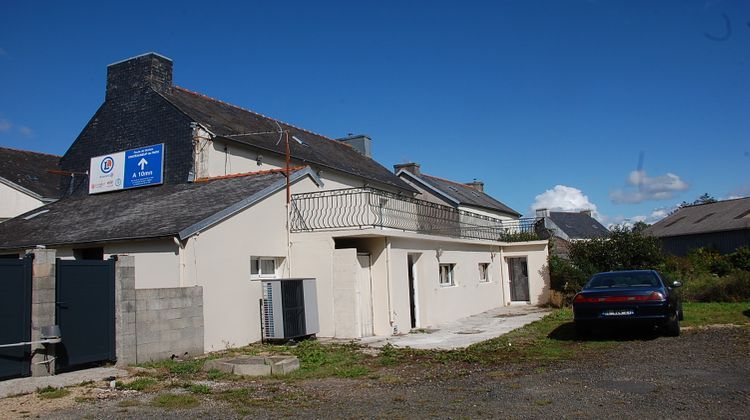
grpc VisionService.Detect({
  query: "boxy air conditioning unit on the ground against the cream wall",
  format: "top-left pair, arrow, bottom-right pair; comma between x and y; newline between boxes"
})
262,279 -> 320,341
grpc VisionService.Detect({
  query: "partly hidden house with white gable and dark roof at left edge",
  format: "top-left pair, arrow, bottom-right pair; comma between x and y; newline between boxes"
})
0,147 -> 60,222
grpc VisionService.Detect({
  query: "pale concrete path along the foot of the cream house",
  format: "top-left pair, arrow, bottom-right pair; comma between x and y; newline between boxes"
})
361,305 -> 551,350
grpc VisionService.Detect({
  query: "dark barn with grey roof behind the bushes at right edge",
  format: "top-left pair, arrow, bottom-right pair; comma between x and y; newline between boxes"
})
645,197 -> 750,255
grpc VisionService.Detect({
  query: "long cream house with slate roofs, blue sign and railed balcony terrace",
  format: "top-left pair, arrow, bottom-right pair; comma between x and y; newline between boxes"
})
0,53 -> 549,370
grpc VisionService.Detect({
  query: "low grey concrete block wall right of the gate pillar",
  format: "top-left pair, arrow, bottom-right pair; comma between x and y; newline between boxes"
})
135,286 -> 203,363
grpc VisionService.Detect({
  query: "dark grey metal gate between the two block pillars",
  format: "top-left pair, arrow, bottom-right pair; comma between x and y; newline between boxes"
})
55,259 -> 115,372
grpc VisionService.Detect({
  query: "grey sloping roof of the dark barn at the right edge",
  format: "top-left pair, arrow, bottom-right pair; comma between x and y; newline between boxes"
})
646,197 -> 750,237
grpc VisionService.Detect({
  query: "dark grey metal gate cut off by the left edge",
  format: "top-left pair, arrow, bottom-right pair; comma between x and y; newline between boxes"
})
0,256 -> 33,379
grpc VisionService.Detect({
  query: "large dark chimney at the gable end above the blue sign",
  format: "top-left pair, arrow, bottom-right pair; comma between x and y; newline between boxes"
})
106,53 -> 172,100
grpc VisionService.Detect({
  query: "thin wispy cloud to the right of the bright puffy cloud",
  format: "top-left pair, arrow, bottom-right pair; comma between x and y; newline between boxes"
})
609,171 -> 690,204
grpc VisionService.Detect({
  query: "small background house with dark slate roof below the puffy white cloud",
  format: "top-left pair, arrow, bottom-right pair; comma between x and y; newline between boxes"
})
536,209 -> 609,259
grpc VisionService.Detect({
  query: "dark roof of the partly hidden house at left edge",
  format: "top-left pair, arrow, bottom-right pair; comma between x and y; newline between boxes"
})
0,147 -> 60,199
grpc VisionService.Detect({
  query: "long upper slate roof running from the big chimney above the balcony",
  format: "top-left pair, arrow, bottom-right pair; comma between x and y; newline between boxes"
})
159,86 -> 417,192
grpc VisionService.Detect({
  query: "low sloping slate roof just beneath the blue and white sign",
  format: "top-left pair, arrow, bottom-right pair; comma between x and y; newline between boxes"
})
0,170 -> 305,249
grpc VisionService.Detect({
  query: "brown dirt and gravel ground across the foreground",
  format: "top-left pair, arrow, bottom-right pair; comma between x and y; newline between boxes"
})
0,327 -> 750,419
